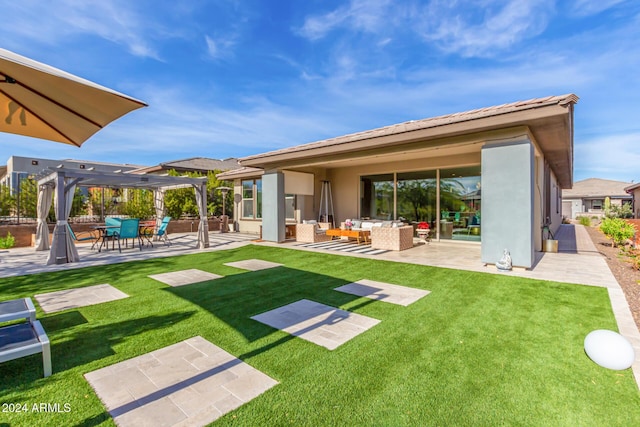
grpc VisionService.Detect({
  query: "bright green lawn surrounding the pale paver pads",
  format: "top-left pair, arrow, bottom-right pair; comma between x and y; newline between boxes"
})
0,246 -> 640,426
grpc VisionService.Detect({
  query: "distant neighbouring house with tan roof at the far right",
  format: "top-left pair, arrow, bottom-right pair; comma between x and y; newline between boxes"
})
562,178 -> 632,219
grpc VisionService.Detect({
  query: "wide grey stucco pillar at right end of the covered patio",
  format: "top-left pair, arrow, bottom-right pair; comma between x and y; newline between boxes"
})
481,140 -> 535,268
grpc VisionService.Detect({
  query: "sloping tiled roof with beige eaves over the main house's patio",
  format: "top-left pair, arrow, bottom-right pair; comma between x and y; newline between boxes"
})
240,94 -> 578,188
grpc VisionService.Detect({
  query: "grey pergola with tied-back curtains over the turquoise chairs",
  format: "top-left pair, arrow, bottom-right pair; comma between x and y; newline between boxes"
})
36,168 -> 209,264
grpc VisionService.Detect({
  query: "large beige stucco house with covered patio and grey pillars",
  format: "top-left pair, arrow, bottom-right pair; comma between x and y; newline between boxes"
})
218,94 -> 578,268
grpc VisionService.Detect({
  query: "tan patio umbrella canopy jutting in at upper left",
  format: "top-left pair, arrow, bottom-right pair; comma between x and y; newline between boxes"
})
0,49 -> 147,147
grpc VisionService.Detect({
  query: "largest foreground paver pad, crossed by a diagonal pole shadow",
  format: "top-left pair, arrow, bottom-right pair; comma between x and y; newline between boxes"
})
84,336 -> 278,427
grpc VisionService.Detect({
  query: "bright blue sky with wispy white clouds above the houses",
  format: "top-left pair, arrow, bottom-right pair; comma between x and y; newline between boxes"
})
0,0 -> 640,182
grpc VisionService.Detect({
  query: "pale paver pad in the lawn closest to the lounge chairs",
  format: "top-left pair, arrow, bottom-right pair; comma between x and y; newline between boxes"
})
35,284 -> 129,313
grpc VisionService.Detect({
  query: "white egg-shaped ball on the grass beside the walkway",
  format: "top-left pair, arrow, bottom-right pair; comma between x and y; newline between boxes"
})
584,329 -> 636,371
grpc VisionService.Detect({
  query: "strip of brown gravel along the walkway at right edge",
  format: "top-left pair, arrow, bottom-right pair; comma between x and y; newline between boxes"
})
585,227 -> 640,330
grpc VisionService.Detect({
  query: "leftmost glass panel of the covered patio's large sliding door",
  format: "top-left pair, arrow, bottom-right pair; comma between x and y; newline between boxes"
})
360,174 -> 394,219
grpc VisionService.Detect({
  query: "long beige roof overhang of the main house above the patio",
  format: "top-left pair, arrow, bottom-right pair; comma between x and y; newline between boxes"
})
240,95 -> 577,188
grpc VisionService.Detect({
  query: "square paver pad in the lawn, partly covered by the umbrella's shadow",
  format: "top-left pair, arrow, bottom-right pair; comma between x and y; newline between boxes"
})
251,299 -> 380,350
